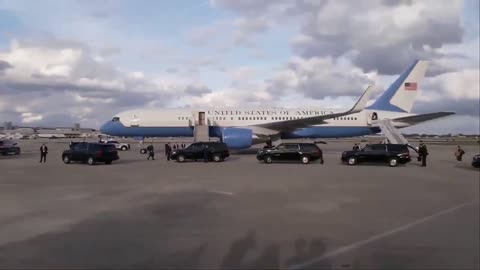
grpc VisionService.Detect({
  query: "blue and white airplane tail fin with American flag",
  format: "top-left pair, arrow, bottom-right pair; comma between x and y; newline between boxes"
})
367,60 -> 428,112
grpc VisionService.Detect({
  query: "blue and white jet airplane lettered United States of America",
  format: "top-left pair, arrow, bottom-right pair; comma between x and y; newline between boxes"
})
100,60 -> 454,149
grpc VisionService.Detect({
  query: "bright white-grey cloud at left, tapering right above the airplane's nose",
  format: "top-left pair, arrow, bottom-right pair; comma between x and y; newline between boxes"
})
0,37 -> 211,126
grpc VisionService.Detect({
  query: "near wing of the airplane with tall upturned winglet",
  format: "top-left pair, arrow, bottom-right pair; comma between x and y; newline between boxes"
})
256,85 -> 373,132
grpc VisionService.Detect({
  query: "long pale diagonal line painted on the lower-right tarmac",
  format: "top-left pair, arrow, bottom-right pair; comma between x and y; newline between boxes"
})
288,200 -> 479,269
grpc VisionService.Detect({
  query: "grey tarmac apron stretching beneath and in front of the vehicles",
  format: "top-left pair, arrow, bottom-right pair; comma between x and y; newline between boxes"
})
0,140 -> 480,269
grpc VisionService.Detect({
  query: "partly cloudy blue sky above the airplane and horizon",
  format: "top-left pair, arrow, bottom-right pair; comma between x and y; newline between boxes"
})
0,0 -> 480,134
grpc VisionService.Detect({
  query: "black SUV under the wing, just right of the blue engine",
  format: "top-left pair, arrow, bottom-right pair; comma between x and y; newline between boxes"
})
257,143 -> 323,164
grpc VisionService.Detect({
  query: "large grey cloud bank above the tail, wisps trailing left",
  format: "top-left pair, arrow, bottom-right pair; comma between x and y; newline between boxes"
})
212,0 -> 464,75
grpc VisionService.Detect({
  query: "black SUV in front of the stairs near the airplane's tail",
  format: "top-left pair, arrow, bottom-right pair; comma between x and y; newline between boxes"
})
342,144 -> 411,167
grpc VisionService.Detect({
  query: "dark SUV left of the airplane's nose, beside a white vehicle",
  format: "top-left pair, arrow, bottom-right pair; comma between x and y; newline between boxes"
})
62,142 -> 118,165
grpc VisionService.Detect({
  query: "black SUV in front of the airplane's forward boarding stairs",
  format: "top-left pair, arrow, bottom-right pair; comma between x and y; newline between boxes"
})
170,142 -> 230,162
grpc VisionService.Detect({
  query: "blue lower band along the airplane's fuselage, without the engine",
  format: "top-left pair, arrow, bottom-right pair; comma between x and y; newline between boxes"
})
100,122 -> 380,139
